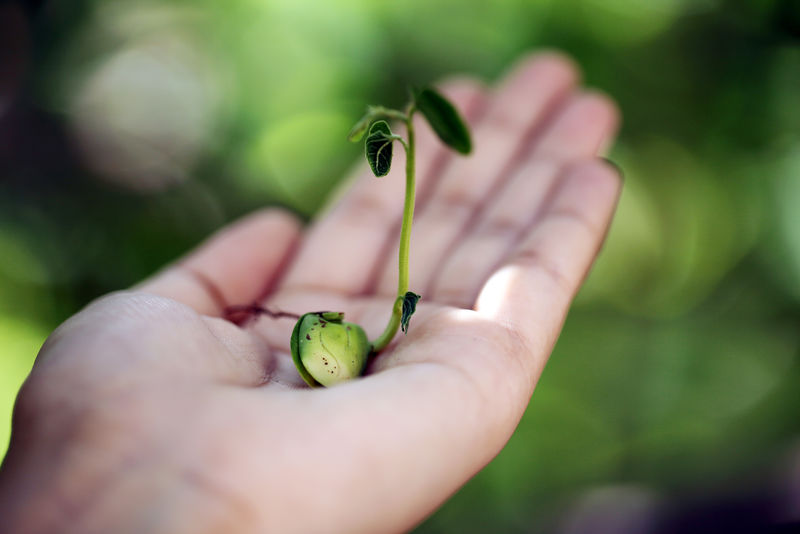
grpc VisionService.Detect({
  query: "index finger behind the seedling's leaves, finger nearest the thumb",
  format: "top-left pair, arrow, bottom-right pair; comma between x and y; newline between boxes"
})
282,79 -> 483,294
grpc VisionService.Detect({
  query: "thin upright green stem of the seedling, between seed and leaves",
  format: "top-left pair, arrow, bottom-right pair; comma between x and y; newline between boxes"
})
372,107 -> 416,352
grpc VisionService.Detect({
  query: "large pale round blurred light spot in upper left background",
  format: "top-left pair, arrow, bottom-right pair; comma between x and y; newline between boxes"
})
70,25 -> 220,191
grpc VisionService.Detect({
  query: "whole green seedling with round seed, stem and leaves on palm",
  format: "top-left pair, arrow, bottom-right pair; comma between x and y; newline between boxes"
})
291,87 -> 472,387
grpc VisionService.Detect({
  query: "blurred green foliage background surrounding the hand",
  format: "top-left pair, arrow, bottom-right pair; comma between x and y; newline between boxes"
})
0,0 -> 800,533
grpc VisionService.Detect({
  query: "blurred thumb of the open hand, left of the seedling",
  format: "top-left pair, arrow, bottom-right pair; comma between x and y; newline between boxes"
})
134,209 -> 300,316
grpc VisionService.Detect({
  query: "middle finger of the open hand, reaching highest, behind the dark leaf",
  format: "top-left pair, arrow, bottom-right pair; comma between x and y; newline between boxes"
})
378,54 -> 578,295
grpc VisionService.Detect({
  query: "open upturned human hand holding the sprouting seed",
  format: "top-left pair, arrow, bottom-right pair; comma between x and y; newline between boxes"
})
0,54 -> 620,533
